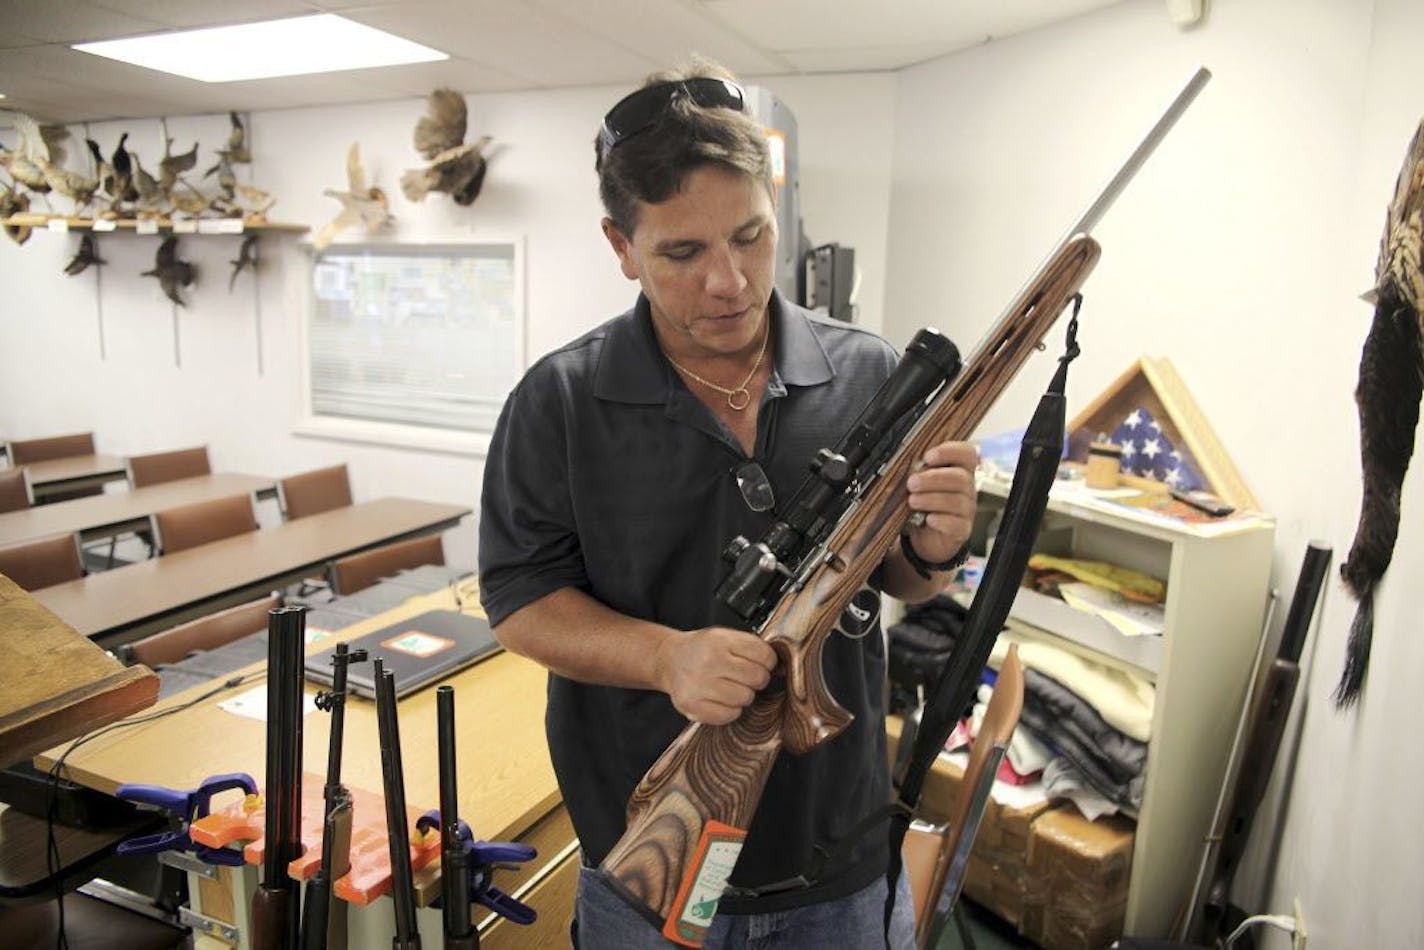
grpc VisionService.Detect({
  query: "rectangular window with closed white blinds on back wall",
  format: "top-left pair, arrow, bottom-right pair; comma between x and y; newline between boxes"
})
305,242 -> 524,447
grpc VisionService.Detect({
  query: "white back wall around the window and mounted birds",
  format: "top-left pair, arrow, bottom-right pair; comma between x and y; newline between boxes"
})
0,74 -> 893,565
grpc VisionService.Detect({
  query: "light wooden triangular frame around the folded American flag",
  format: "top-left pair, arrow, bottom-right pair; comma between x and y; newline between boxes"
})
1068,356 -> 1259,511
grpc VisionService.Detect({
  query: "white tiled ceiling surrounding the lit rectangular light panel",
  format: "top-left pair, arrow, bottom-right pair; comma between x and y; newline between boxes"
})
0,0 -> 1121,121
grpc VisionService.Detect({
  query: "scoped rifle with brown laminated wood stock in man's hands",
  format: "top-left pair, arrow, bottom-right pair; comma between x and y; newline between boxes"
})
600,70 -> 1210,947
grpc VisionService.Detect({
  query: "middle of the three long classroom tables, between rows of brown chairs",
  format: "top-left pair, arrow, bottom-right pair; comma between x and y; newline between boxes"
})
0,471 -> 276,546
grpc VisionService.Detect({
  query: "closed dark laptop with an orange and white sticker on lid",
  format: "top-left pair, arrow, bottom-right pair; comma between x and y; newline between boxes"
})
306,610 -> 500,699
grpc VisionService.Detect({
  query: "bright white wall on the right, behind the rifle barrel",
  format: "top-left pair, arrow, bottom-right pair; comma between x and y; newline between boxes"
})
884,0 -> 1424,947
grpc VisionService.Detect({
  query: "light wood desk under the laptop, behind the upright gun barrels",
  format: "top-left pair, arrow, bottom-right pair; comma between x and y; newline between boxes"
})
36,589 -> 566,950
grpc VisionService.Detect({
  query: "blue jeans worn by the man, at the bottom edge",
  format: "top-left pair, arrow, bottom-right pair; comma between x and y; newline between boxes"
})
572,866 -> 914,950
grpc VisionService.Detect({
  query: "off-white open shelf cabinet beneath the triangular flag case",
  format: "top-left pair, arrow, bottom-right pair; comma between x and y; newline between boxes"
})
977,481 -> 1274,937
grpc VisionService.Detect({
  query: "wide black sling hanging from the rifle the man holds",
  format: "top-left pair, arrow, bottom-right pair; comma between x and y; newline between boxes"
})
884,306 -> 1082,943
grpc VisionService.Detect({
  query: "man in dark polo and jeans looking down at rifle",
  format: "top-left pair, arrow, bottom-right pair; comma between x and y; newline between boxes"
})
480,63 -> 977,949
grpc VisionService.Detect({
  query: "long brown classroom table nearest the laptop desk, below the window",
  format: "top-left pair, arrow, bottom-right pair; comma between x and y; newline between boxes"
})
34,499 -> 470,649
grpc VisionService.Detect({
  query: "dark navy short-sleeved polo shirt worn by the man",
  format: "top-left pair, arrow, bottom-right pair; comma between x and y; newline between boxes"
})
480,292 -> 899,913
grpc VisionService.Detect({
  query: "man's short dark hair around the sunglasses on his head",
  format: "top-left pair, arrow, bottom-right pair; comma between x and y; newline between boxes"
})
594,60 -> 776,238
